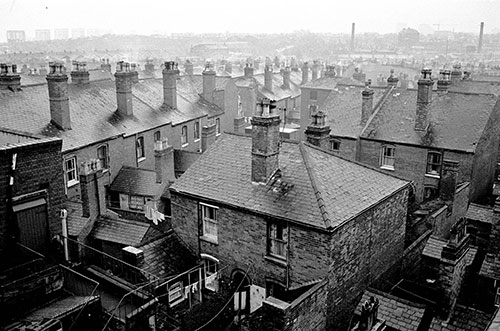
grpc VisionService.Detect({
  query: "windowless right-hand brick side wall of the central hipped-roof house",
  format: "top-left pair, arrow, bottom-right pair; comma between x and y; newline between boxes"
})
327,189 -> 408,329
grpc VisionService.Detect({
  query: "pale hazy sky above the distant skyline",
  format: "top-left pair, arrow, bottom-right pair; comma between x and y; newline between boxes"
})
0,0 -> 500,41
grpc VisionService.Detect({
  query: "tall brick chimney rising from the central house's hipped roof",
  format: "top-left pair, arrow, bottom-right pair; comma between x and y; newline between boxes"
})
251,98 -> 281,183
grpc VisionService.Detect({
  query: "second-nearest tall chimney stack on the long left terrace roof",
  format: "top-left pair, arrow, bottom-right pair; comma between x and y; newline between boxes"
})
115,61 -> 135,116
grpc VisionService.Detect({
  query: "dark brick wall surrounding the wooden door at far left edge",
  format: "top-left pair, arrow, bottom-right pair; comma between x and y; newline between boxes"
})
0,140 -> 64,247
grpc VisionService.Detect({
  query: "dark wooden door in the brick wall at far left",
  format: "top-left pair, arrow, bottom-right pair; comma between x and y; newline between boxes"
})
14,203 -> 48,252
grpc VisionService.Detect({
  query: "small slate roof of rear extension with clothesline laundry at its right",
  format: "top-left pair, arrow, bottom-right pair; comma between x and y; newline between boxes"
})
110,166 -> 169,197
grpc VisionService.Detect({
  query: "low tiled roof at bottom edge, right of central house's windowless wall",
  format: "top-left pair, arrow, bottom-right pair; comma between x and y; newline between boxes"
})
355,289 -> 426,331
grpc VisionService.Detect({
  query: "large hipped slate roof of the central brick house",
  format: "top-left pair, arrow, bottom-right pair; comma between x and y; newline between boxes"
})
171,134 -> 408,229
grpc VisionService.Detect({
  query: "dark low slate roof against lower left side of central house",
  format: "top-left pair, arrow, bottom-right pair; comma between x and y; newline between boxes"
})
138,231 -> 196,278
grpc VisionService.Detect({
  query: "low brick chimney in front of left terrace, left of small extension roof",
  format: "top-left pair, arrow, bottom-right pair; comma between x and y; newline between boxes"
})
80,159 -> 106,220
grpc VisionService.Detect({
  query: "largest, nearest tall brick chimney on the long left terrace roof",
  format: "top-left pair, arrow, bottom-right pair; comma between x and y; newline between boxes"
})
47,62 -> 71,130
